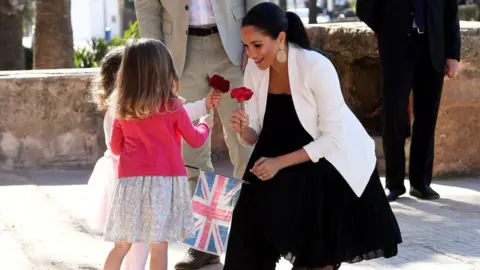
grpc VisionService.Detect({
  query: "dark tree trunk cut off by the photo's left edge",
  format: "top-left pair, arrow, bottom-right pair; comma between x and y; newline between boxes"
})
0,0 -> 25,70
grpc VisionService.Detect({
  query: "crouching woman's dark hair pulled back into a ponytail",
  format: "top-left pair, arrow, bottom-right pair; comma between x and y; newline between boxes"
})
242,2 -> 311,50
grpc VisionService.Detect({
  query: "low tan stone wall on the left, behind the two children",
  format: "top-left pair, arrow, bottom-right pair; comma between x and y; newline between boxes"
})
0,69 -> 226,169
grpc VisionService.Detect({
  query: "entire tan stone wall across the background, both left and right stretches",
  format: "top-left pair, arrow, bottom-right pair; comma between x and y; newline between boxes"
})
0,22 -> 480,176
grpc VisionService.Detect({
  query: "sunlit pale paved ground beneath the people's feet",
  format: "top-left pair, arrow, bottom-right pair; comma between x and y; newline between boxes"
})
0,161 -> 480,270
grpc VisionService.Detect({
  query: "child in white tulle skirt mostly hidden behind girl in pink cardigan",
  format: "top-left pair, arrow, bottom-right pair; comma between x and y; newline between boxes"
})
87,40 -> 220,270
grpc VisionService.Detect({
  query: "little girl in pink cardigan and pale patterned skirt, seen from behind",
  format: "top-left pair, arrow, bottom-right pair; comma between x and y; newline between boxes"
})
104,39 -> 212,270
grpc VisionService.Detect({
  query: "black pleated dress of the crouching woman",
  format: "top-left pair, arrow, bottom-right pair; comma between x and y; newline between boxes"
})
224,94 -> 402,270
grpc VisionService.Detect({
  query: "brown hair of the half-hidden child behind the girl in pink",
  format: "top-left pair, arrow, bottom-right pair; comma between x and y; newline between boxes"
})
90,47 -> 124,112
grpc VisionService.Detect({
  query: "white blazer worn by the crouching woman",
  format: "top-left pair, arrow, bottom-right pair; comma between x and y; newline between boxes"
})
244,45 -> 376,197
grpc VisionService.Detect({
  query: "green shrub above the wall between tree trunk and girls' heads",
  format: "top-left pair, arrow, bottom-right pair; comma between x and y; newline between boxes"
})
74,22 -> 140,68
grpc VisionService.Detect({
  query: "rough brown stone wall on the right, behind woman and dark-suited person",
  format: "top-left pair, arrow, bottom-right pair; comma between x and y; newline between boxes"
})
308,22 -> 480,177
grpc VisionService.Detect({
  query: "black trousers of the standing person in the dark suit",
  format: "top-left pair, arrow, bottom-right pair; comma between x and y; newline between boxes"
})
379,33 -> 444,190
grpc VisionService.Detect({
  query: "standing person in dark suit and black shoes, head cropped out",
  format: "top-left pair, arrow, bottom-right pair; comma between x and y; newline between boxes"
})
357,0 -> 460,201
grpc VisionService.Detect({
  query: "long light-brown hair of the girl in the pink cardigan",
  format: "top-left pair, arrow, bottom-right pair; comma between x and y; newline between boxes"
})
116,38 -> 179,120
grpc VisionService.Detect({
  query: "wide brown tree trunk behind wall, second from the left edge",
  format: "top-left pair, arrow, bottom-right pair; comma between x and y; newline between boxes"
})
33,0 -> 74,69
